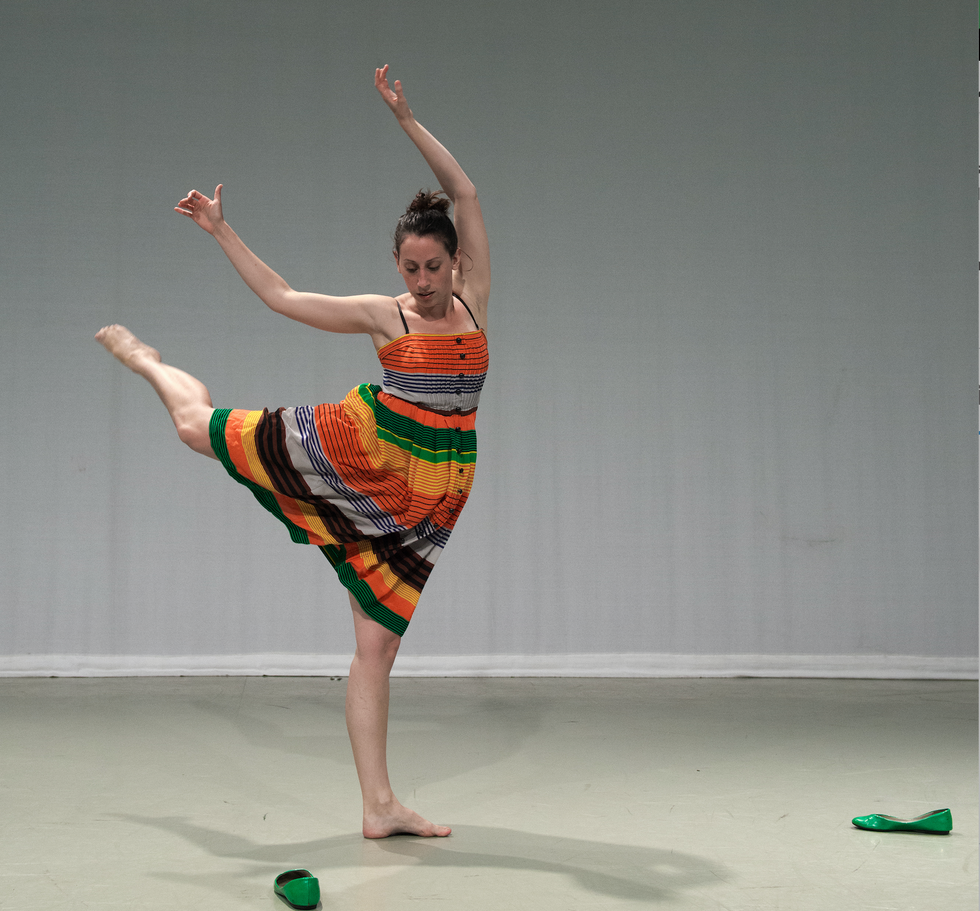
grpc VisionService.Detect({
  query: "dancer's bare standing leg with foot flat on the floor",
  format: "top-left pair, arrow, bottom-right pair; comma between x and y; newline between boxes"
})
347,595 -> 451,838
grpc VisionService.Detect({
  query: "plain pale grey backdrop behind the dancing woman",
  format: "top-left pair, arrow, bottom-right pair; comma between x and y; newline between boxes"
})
0,0 -> 977,670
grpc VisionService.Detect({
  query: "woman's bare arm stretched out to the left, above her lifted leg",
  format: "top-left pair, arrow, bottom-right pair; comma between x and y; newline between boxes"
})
174,184 -> 391,344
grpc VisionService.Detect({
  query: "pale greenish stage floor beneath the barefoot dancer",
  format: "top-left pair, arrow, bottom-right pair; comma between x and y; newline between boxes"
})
0,678 -> 978,911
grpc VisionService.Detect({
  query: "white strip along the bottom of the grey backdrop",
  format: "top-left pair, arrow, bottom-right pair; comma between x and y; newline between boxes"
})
0,654 -> 980,680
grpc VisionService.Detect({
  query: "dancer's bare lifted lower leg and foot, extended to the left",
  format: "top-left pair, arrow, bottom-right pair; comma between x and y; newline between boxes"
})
95,326 -> 217,459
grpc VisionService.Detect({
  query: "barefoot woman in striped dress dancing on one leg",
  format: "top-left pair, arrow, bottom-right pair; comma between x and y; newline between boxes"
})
96,65 -> 490,838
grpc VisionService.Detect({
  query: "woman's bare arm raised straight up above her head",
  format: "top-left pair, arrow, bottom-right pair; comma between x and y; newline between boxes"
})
374,64 -> 490,325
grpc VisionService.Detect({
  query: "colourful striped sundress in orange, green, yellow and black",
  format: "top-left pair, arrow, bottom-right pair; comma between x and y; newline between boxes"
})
210,302 -> 489,636
